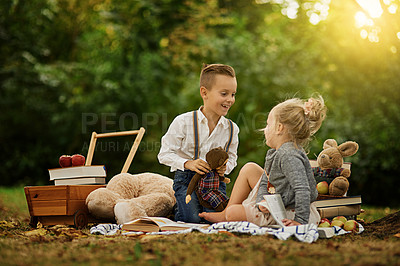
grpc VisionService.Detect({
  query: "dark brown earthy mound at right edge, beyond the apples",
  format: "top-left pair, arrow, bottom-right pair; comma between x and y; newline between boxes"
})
362,211 -> 400,238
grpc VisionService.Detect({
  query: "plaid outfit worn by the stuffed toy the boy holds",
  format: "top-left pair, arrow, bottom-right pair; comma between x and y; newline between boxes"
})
197,171 -> 228,209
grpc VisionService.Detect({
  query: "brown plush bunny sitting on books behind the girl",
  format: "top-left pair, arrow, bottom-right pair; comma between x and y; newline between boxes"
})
313,139 -> 358,196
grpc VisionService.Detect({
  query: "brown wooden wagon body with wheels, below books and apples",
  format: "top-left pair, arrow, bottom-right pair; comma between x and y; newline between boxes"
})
24,185 -> 106,228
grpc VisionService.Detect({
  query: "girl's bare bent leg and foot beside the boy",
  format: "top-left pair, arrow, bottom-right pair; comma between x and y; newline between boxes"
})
199,163 -> 264,223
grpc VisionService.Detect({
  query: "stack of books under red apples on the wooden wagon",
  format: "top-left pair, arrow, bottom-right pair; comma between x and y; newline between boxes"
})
49,165 -> 107,185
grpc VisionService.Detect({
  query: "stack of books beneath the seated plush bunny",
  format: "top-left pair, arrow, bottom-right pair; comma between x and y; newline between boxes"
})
314,196 -> 361,218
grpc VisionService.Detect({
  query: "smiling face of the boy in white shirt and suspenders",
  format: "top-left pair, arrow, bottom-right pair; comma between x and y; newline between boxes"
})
200,75 -> 237,116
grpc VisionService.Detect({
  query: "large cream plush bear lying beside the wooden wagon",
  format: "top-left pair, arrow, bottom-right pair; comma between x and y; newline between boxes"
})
86,173 -> 176,224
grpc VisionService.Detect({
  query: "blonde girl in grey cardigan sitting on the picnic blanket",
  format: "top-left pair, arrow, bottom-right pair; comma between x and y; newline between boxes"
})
199,96 -> 326,226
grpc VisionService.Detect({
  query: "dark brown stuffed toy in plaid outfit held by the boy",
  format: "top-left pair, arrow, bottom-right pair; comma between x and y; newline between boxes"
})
186,147 -> 231,211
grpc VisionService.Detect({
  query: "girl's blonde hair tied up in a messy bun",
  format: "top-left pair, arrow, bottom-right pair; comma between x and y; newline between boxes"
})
273,95 -> 326,147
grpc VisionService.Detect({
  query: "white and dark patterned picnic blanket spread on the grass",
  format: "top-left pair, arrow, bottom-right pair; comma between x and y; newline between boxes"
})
90,221 -> 364,243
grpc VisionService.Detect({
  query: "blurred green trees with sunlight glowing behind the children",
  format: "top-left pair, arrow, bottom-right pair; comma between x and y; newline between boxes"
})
0,0 -> 400,206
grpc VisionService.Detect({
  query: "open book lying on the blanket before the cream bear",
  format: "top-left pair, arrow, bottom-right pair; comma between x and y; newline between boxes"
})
122,217 -> 210,232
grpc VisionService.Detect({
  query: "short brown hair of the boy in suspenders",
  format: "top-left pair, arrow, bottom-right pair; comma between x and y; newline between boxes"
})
200,64 -> 236,90
